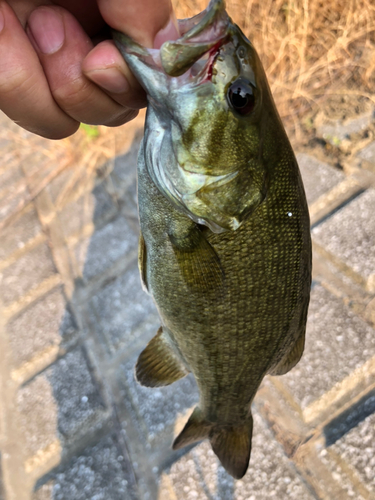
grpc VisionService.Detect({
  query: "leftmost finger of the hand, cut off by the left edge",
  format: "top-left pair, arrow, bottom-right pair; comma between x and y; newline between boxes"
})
0,1 -> 79,139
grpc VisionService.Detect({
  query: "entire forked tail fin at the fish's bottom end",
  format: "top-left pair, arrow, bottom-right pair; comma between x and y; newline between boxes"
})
173,407 -> 253,479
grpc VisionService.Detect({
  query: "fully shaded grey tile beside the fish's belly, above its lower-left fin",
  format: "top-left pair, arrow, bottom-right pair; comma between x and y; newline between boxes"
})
89,262 -> 160,353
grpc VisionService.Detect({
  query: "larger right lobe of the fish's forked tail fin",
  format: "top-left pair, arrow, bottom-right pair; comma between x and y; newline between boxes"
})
210,415 -> 253,479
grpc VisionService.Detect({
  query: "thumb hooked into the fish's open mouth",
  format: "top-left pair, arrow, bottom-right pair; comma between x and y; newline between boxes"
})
98,0 -> 179,48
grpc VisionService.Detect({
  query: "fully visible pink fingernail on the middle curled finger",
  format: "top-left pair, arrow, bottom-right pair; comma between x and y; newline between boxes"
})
28,7 -> 65,54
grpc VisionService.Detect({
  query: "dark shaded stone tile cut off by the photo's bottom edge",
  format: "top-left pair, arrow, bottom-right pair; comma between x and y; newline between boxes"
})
33,436 -> 138,500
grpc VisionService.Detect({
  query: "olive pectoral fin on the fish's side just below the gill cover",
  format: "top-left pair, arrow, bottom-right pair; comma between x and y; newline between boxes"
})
169,225 -> 225,293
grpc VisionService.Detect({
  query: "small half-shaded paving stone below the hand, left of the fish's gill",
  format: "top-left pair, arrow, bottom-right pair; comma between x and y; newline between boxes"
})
59,183 -> 116,237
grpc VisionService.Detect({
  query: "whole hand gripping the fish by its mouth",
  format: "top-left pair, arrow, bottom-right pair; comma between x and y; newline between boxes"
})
0,0 -> 179,139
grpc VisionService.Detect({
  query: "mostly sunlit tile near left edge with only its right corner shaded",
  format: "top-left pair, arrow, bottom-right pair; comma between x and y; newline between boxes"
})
6,287 -> 77,366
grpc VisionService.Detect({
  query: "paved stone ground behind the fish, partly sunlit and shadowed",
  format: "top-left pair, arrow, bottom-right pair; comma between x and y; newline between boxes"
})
0,101 -> 375,500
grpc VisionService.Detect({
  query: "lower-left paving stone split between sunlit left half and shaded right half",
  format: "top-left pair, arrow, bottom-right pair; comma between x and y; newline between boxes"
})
17,348 -> 104,455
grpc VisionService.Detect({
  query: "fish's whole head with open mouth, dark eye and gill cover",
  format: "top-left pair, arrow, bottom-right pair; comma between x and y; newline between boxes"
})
114,0 -> 267,232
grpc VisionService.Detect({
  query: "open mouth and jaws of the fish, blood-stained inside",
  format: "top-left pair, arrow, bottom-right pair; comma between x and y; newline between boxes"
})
113,0 -> 231,88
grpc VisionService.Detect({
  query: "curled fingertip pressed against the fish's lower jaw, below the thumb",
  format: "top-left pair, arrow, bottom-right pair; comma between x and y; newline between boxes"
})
82,40 -> 147,109
